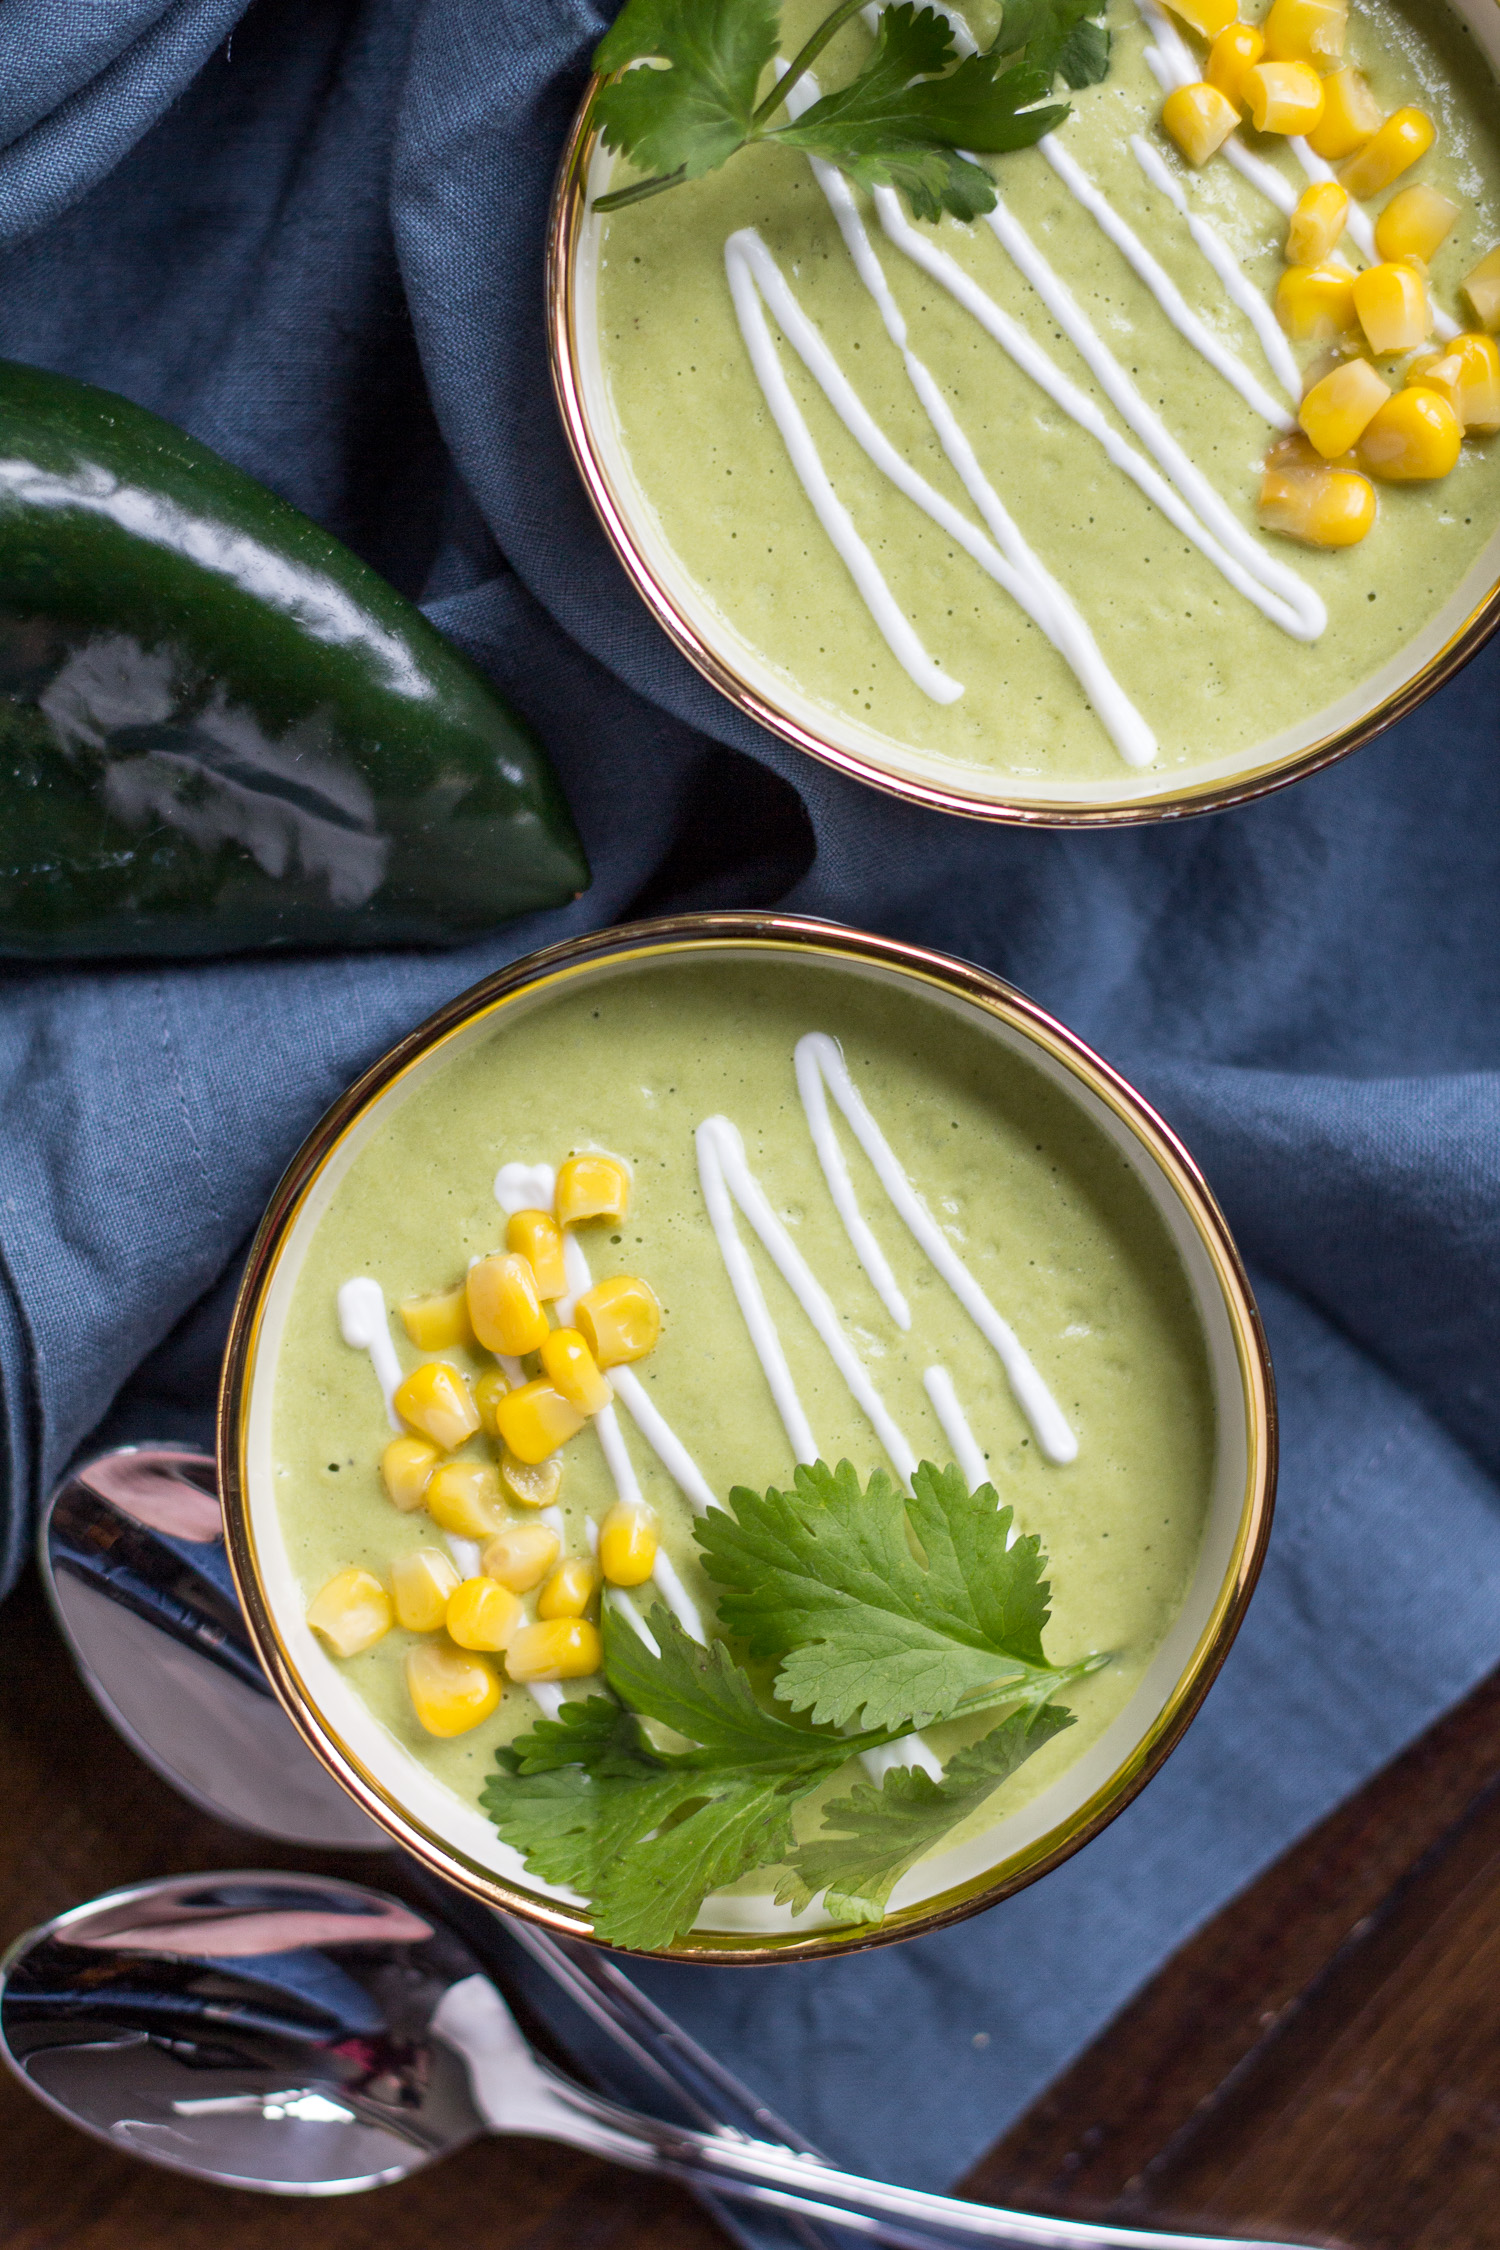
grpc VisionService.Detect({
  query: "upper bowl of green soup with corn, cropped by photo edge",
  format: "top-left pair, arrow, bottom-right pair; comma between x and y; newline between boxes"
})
549,0 -> 1500,826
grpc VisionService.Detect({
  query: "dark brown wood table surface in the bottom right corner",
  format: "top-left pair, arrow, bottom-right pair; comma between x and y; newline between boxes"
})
965,1674 -> 1500,2250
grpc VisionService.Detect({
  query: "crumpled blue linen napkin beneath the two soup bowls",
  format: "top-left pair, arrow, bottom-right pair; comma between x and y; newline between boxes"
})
0,0 -> 1500,2185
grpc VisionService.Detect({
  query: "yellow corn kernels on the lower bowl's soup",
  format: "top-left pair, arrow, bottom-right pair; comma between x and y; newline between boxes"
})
308,1154 -> 661,1737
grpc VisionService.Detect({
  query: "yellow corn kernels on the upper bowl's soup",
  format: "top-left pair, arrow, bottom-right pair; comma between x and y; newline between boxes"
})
1160,0 -> 1500,547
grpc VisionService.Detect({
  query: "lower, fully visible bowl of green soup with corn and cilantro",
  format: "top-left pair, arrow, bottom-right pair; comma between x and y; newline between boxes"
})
220,914 -> 1275,1960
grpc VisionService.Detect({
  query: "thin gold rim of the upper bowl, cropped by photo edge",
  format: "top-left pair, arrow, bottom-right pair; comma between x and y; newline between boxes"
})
546,72 -> 1500,828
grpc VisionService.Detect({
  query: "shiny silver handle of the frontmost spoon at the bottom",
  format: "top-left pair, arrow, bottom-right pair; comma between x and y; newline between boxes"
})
432,1978 -> 1291,2250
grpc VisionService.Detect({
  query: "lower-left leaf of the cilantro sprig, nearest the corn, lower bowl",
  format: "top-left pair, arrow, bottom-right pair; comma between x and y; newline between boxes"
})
481,1607 -> 859,1951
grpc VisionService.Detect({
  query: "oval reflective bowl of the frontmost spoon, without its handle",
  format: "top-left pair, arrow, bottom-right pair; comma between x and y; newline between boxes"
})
0,1874 -> 484,2196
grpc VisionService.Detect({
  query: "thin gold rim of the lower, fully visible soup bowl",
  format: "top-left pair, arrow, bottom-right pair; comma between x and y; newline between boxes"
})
218,914 -> 1277,1964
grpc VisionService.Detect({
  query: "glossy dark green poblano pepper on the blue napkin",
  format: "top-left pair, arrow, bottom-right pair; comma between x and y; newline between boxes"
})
0,362 -> 589,959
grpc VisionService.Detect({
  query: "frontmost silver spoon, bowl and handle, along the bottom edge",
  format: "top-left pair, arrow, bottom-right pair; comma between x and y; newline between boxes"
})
0,1874 -> 1313,2250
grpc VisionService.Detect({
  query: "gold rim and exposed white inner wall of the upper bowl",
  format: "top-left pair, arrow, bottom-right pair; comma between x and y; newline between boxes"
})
546,19 -> 1500,828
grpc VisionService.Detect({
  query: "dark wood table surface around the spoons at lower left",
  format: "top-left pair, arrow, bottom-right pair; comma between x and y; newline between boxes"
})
0,1580 -> 726,2250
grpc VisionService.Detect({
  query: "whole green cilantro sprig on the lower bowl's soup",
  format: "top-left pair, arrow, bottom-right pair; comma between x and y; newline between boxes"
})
481,1463 -> 1104,1951
